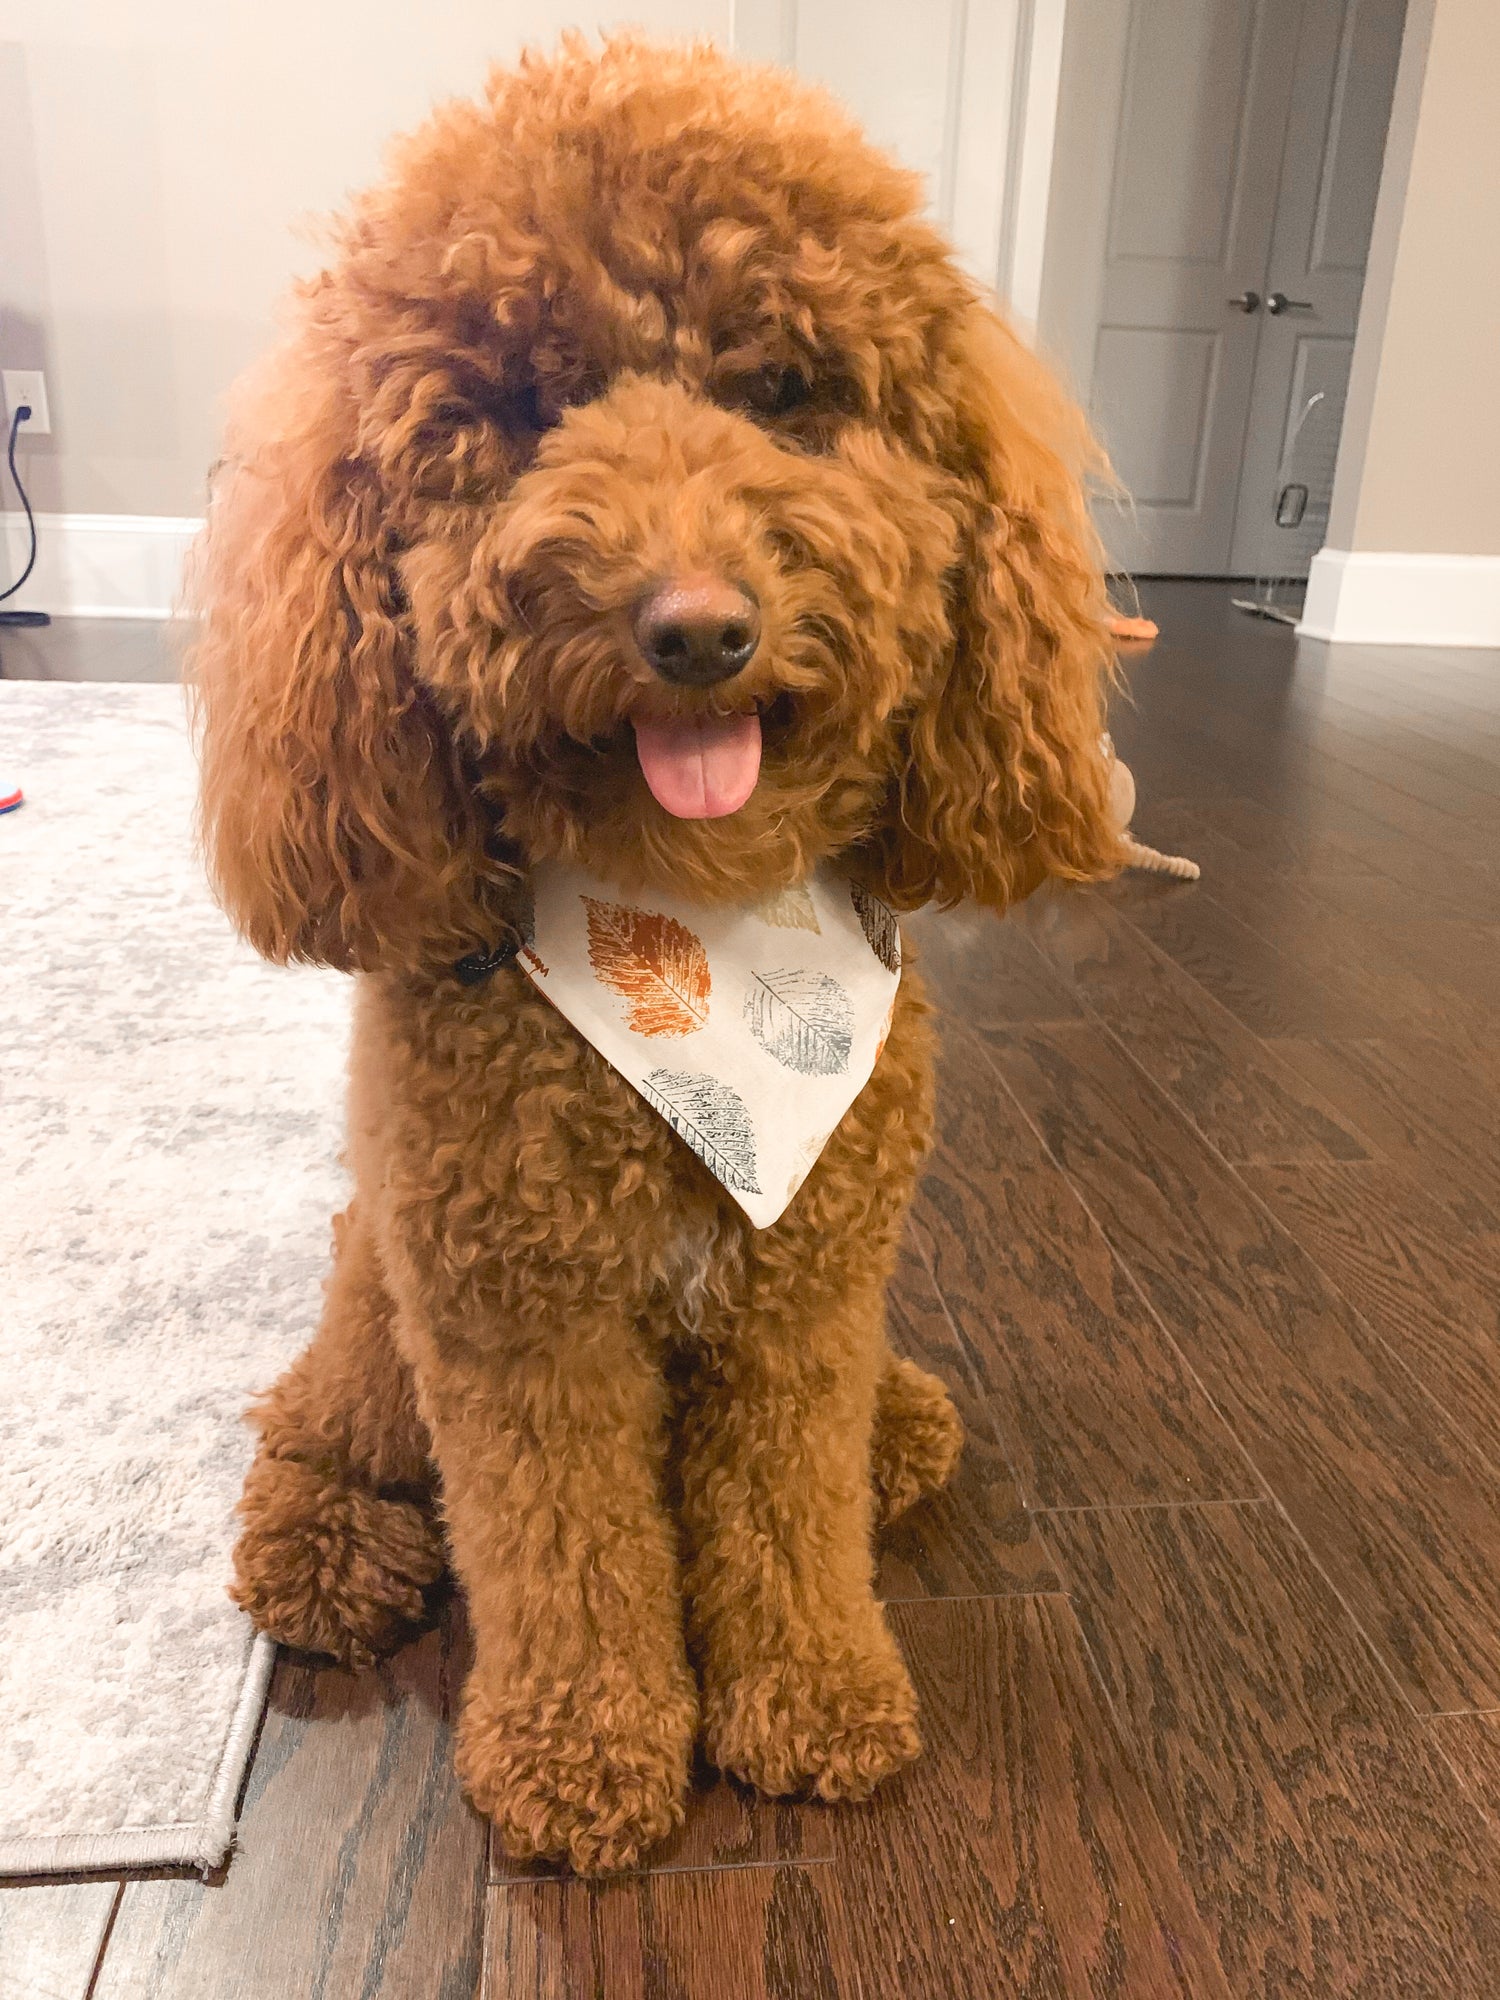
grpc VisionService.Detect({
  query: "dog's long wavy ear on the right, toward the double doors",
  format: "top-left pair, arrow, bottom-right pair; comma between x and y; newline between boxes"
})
878,304 -> 1118,910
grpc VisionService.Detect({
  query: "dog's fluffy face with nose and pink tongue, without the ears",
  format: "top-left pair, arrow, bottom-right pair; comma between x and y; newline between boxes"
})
402,370 -> 956,900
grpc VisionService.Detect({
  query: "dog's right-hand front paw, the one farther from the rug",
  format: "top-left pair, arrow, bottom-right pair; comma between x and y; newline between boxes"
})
704,1632 -> 922,1800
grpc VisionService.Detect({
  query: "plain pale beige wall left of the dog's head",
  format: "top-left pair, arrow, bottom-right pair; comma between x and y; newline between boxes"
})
0,0 -> 732,514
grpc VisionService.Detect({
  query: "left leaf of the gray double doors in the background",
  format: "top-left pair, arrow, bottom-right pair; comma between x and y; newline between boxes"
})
1090,0 -> 1302,576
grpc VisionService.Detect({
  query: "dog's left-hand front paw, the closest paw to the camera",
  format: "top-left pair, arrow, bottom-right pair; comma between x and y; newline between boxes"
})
458,1676 -> 698,1876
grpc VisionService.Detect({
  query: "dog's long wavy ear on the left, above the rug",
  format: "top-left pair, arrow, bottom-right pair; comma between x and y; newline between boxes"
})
190,348 -> 508,970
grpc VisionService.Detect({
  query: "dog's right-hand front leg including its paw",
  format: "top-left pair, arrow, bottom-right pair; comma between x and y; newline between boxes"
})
682,1270 -> 920,1800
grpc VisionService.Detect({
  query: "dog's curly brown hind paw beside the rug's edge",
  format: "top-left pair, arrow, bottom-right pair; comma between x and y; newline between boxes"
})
230,1458 -> 446,1668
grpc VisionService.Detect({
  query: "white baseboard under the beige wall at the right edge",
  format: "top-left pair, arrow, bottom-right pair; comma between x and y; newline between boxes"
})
1298,548 -> 1500,646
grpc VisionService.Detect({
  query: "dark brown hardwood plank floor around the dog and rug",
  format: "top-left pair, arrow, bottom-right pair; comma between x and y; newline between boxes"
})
0,584 -> 1500,2000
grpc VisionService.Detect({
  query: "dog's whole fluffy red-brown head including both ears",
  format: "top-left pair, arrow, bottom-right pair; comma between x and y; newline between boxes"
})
194,31 -> 1114,968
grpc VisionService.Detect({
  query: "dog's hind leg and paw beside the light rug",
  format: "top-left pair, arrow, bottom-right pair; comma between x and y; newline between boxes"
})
230,1206 -> 446,1666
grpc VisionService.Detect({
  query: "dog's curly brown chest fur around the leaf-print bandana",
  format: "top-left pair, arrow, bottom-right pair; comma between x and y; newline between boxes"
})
362,970 -> 930,1312
